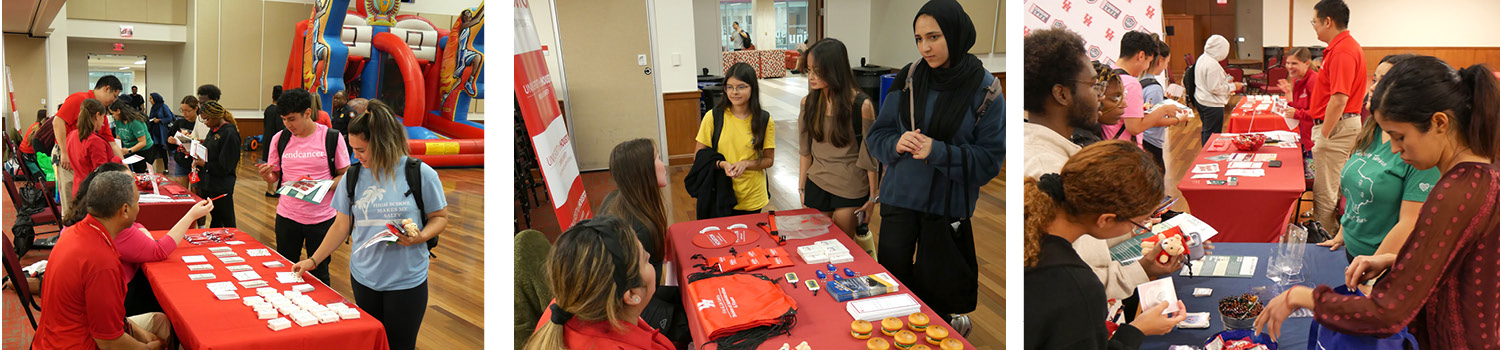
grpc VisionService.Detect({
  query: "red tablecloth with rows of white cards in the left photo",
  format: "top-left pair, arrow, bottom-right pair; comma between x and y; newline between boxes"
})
143,228 -> 390,350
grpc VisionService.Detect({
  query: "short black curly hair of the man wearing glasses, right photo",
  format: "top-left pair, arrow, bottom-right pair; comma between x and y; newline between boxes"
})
1023,29 -> 1089,114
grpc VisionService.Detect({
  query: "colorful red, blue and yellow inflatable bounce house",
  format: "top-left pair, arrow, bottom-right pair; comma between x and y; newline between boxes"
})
282,0 -> 485,167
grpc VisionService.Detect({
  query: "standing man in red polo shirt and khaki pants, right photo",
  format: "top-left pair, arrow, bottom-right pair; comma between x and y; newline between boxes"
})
1313,0 -> 1368,234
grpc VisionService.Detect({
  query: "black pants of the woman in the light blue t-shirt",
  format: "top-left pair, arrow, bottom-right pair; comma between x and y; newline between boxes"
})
350,276 -> 428,350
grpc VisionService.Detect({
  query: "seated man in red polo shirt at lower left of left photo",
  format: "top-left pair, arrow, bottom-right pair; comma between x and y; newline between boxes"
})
32,171 -> 171,348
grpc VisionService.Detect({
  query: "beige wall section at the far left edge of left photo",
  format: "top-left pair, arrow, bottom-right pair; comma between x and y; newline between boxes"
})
3,33 -> 60,118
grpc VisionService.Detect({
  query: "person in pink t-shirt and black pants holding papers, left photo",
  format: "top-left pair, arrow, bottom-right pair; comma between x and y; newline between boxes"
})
257,89 -> 350,285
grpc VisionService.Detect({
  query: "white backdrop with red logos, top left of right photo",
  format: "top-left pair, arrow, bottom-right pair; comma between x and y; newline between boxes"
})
1023,0 -> 1164,65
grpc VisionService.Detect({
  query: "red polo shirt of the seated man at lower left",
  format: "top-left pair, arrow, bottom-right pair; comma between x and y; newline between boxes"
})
33,215 -> 125,348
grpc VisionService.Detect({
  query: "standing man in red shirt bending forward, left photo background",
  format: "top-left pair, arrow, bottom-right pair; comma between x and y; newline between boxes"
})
53,75 -> 125,213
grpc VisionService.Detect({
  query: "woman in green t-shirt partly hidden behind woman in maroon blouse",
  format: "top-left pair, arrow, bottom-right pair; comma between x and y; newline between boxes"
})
1319,54 -> 1440,261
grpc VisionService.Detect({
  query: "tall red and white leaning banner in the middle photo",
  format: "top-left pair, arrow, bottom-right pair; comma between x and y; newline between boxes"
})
515,0 -> 594,230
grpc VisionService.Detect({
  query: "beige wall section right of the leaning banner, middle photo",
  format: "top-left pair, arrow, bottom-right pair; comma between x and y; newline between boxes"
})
554,0 -> 662,170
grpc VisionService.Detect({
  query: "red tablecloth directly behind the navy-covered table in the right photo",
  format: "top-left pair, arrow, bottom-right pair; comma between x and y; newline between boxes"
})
1178,134 -> 1307,243
